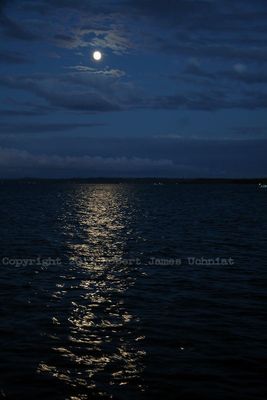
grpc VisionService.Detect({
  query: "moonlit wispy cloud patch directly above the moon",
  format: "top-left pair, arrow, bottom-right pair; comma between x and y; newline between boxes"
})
20,0 -> 133,54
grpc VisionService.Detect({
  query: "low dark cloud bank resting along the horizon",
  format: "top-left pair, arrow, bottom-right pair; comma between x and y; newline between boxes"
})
0,138 -> 267,177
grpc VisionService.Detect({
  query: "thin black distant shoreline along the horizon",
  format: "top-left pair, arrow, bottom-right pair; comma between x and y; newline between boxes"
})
0,177 -> 267,185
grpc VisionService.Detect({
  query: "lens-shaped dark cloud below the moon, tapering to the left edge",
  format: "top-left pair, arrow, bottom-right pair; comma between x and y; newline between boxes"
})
0,70 -> 141,113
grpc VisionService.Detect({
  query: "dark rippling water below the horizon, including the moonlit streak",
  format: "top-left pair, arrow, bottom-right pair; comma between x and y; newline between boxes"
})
0,182 -> 267,400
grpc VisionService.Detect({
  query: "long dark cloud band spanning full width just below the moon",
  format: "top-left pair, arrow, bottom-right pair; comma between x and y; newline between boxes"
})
0,69 -> 267,113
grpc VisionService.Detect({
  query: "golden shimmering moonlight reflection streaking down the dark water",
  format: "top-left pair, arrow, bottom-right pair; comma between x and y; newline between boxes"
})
38,186 -> 145,393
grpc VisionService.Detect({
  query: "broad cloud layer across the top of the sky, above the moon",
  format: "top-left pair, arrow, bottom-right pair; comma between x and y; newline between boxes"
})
2,0 -> 267,64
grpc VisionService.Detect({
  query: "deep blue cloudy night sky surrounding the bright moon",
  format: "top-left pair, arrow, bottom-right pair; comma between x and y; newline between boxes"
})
0,0 -> 267,178
